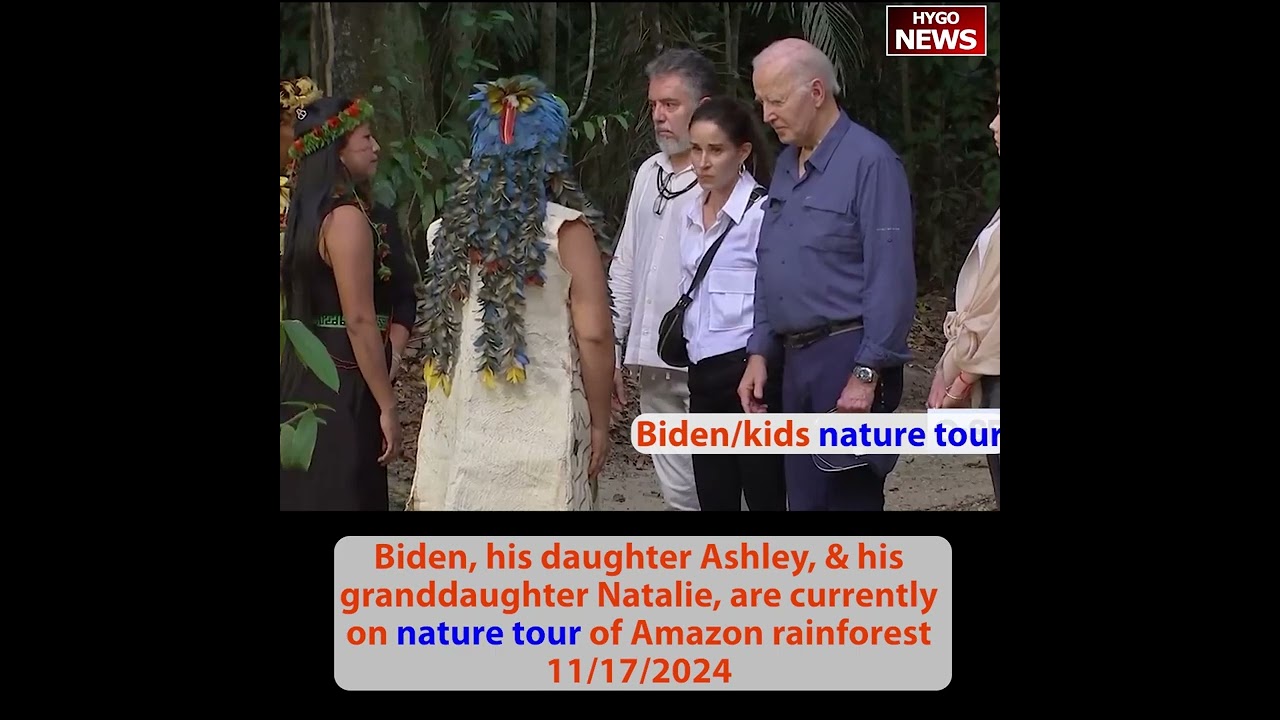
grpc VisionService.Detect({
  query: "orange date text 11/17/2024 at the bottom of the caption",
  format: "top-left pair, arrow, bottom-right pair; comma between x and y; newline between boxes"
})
547,657 -> 733,685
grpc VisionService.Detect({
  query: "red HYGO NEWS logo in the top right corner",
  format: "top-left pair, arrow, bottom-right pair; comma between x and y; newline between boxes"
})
884,5 -> 987,58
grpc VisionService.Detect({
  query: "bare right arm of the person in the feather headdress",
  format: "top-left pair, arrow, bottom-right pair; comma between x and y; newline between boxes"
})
559,220 -> 614,430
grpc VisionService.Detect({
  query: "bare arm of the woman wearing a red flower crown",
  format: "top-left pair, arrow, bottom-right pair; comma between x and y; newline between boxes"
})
323,205 -> 396,413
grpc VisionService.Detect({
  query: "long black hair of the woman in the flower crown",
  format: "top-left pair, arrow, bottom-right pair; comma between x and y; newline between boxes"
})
280,97 -> 361,323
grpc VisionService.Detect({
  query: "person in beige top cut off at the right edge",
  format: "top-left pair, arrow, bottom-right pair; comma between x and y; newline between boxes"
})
929,87 -> 1000,510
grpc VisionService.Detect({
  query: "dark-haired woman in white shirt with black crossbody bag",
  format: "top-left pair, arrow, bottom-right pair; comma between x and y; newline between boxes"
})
680,97 -> 787,511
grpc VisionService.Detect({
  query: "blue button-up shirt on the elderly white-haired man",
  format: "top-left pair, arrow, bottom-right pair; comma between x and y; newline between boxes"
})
748,111 -> 915,368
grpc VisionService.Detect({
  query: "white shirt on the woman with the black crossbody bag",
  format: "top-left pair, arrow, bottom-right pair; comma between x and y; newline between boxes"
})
677,172 -> 769,364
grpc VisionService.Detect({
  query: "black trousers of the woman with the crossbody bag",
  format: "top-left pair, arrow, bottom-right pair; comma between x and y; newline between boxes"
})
689,348 -> 787,512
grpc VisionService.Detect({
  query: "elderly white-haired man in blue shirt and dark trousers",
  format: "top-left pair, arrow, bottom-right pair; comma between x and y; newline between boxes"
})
739,38 -> 915,511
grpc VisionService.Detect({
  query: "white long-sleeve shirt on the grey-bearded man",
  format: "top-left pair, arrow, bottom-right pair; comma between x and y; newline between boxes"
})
609,147 -> 699,370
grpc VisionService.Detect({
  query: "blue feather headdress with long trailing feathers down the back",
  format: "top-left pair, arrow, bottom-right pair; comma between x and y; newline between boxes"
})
424,76 -> 607,393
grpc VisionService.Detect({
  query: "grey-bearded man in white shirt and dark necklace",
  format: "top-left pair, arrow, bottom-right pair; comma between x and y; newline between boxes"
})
609,49 -> 719,510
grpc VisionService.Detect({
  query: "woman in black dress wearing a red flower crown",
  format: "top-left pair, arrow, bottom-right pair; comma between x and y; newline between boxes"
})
280,97 -> 401,511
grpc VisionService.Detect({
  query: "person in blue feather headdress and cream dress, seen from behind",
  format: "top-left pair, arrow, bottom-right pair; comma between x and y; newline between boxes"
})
410,77 -> 614,510
